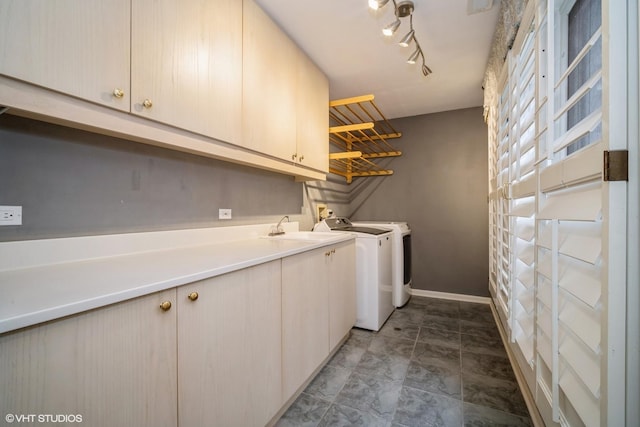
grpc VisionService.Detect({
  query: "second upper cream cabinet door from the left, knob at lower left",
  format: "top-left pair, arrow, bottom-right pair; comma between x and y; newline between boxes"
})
131,0 -> 242,144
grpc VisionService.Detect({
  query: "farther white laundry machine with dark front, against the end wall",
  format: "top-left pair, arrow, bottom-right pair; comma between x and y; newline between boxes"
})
352,221 -> 412,307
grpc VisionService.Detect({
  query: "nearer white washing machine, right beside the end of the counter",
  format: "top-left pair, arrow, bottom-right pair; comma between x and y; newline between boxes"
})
313,218 -> 394,331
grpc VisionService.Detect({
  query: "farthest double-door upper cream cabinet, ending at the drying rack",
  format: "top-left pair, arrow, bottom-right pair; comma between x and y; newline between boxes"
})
242,0 -> 329,173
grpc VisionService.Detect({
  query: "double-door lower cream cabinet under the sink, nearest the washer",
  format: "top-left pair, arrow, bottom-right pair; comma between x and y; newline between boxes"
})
282,242 -> 356,401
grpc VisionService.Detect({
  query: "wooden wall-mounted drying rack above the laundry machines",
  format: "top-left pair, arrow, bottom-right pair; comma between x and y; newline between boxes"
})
329,95 -> 402,184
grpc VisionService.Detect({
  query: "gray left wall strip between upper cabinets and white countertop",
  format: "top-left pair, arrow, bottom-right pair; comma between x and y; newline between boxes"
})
0,114 -> 303,241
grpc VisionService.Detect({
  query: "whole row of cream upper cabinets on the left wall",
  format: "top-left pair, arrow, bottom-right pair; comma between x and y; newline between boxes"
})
0,0 -> 329,179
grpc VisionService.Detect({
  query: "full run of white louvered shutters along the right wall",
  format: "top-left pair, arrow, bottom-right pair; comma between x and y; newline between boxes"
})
490,0 -> 627,426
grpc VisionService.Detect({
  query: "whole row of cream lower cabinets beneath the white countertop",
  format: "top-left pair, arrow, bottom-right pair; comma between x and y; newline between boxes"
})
0,242 -> 356,427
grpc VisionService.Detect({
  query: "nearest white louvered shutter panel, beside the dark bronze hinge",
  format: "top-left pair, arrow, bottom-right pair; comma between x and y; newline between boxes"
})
537,1 -> 603,426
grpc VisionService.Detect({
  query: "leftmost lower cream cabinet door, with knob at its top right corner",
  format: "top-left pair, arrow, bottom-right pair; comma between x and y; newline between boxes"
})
0,290 -> 177,427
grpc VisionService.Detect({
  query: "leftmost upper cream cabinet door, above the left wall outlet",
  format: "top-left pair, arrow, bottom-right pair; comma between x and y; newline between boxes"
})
0,0 -> 135,111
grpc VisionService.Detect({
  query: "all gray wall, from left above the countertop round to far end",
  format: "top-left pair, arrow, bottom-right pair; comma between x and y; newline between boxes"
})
0,108 -> 488,296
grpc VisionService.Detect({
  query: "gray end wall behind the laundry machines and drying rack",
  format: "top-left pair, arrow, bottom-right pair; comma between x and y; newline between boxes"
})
350,108 -> 489,296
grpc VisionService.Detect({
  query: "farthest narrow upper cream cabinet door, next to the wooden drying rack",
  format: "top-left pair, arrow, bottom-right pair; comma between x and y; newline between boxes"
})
296,52 -> 329,173
